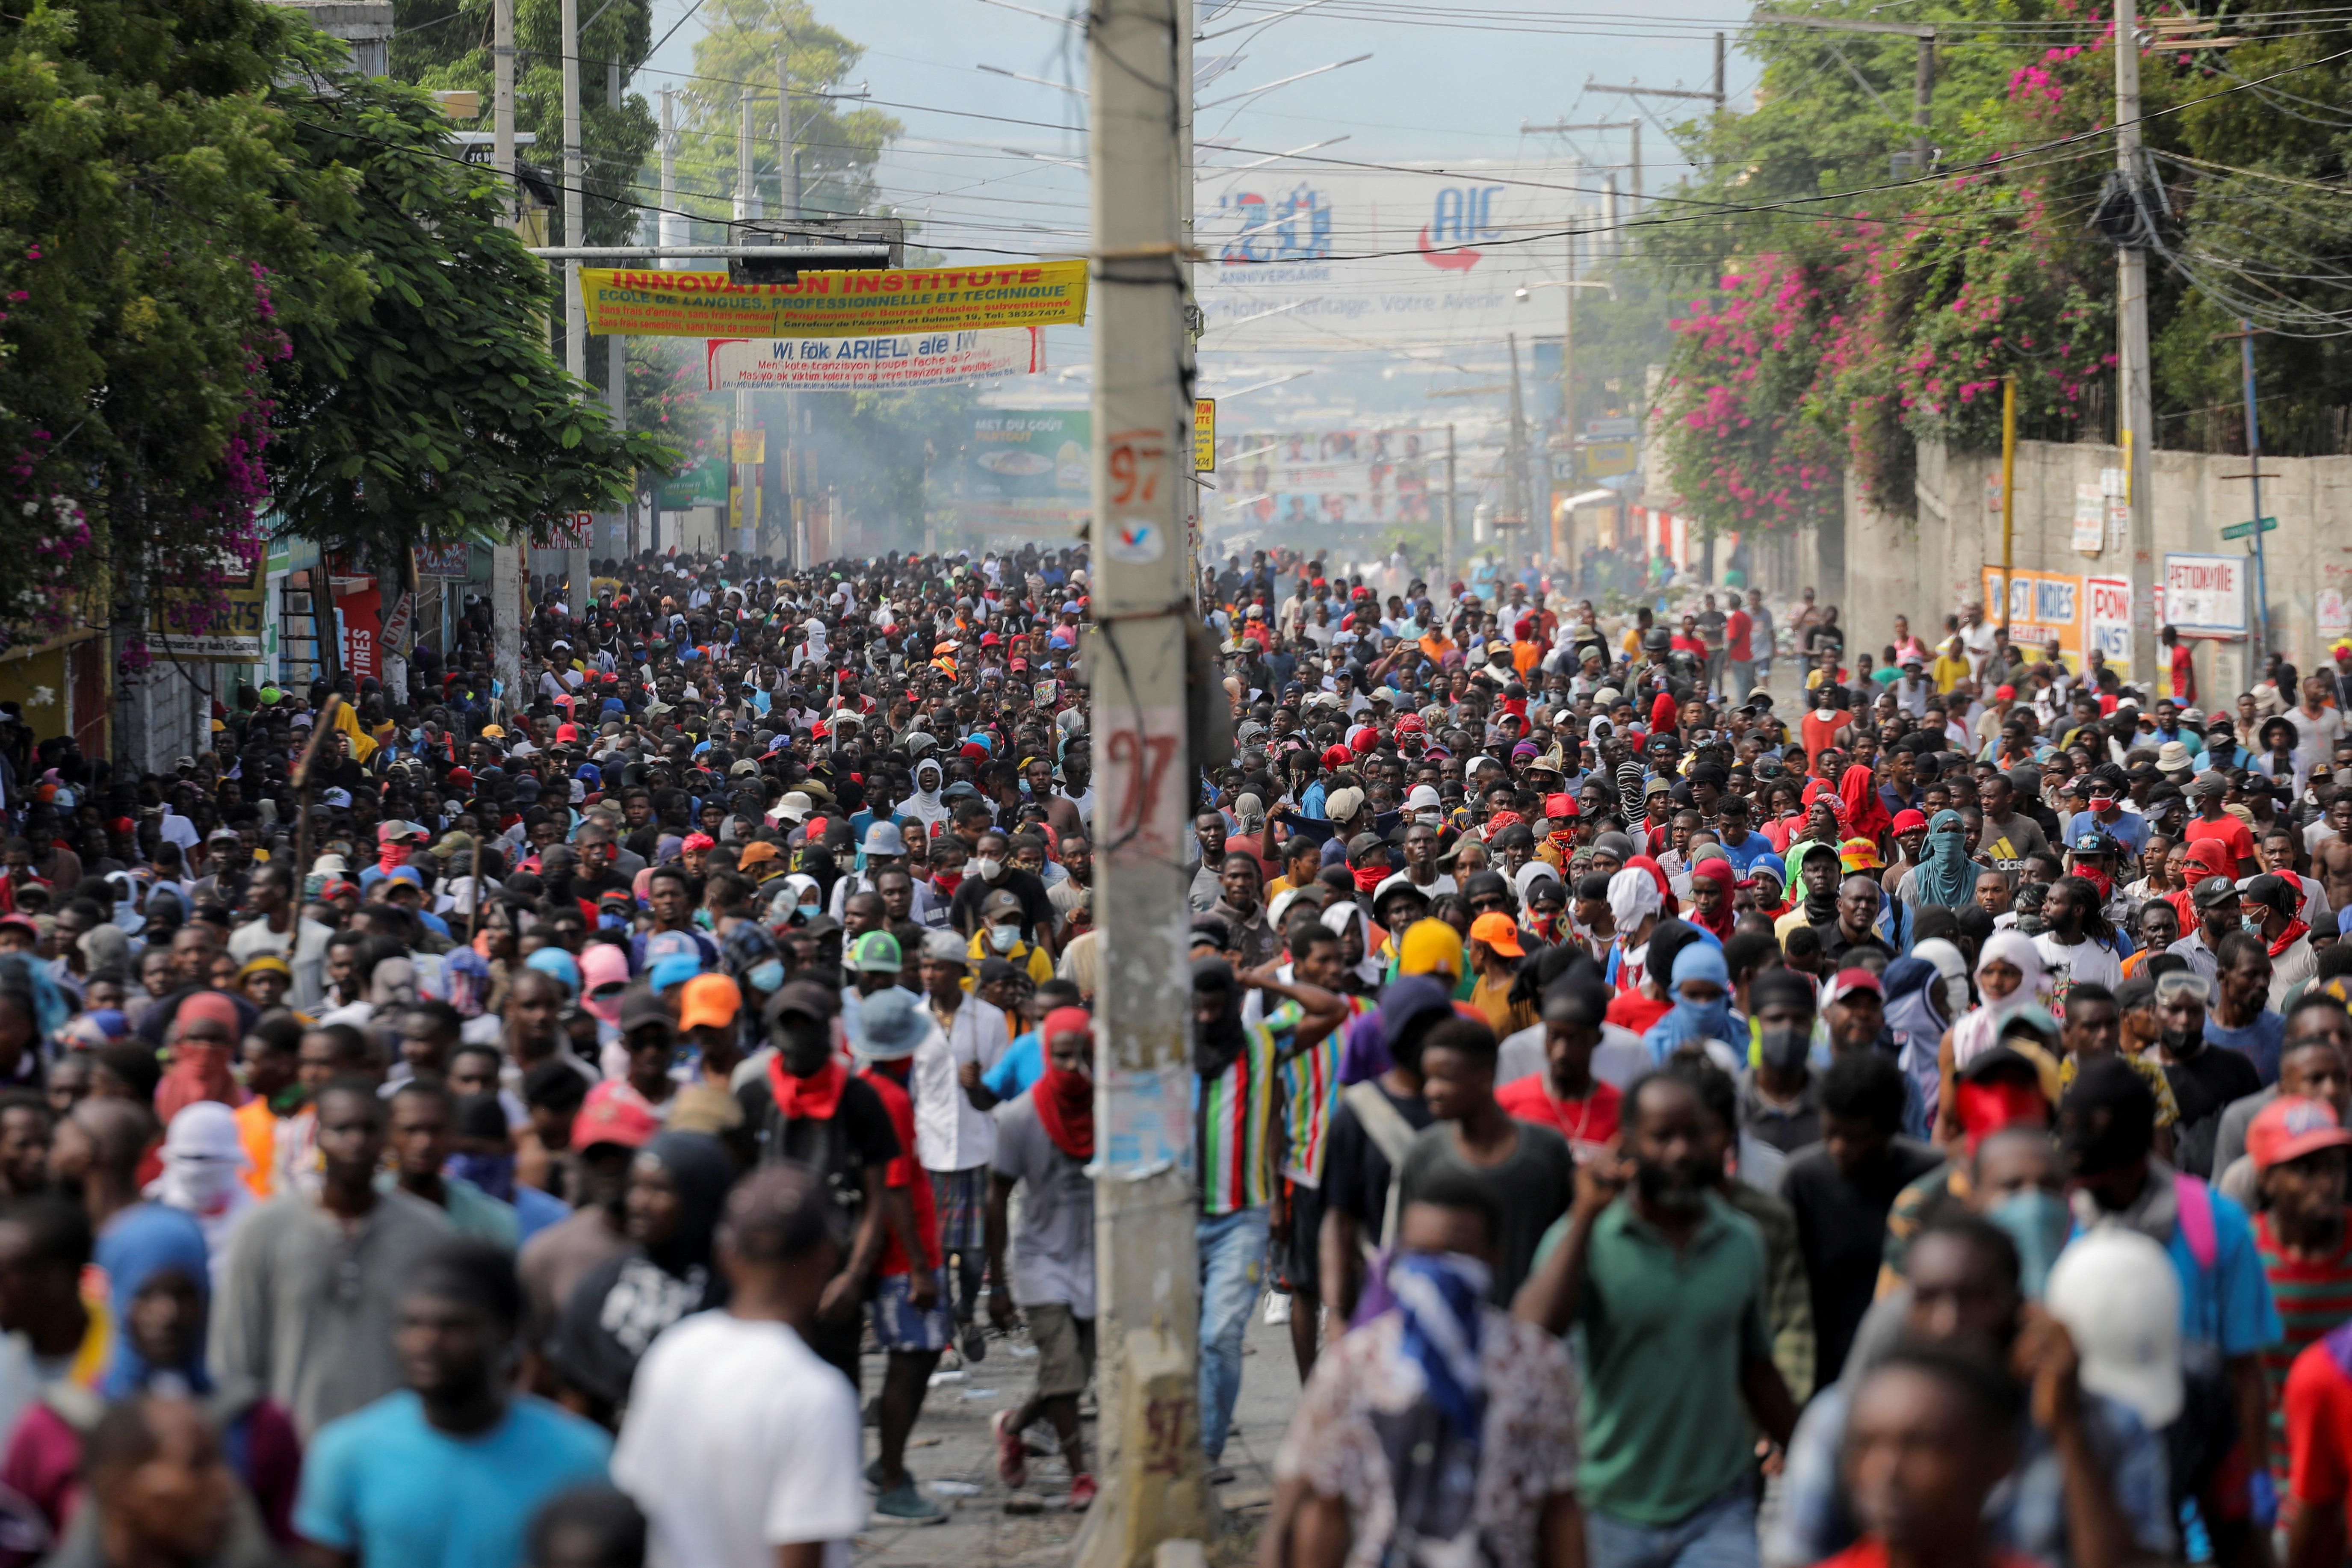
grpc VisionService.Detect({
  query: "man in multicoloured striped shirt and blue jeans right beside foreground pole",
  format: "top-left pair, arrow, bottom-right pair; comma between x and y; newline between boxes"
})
1193,957 -> 1348,1472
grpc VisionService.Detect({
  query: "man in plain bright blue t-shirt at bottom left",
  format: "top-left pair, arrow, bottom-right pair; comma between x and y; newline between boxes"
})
294,1237 -> 612,1568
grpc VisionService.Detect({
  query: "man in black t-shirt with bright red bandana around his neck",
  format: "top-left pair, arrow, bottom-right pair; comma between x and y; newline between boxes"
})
736,980 -> 898,1387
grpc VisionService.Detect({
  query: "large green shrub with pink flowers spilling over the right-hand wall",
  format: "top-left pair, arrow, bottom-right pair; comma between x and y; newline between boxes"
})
1661,0 -> 2115,531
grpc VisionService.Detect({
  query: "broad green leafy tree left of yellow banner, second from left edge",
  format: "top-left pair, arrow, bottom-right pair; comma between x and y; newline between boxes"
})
273,44 -> 677,559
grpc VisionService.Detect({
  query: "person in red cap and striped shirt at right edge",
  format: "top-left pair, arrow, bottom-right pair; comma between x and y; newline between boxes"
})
2246,1096 -> 2352,1495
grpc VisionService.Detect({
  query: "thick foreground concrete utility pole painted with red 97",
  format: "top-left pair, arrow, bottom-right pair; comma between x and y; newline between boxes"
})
1077,0 -> 1223,1542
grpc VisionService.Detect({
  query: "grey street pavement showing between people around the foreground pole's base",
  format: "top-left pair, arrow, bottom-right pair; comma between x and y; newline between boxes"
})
851,1305 -> 1298,1568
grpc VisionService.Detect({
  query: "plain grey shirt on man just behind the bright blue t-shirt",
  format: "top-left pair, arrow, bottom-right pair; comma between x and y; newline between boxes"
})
212,1192 -> 452,1444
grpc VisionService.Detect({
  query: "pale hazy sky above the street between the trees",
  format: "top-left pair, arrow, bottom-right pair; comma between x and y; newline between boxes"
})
635,0 -> 1757,421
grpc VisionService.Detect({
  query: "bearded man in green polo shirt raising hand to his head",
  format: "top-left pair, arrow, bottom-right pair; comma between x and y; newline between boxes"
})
1517,1074 -> 1797,1568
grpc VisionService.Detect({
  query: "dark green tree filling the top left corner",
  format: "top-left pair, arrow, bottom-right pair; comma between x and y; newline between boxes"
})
0,0 -> 336,635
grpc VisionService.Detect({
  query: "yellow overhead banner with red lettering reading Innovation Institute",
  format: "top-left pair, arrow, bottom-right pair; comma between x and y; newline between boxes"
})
581,261 -> 1087,339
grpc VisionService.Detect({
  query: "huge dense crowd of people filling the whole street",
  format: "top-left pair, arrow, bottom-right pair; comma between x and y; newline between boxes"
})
0,536 -> 2352,1568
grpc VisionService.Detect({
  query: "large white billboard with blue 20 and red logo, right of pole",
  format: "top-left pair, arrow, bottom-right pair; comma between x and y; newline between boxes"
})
1193,157 -> 1590,350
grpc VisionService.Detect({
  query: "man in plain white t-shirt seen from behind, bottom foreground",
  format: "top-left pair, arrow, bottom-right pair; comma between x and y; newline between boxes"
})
612,1163 -> 866,1568
